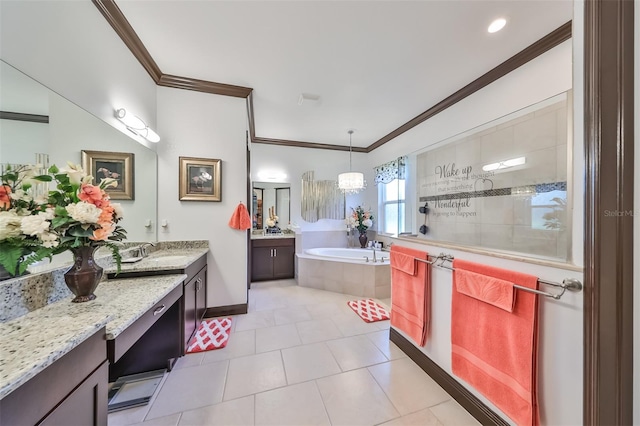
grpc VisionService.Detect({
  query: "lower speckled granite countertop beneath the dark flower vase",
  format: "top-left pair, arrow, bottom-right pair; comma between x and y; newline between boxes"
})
0,272 -> 185,399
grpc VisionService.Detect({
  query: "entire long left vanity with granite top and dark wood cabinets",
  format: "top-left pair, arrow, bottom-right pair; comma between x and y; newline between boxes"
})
0,241 -> 208,425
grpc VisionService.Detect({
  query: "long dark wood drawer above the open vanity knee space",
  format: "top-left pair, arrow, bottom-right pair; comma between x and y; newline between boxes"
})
107,285 -> 182,363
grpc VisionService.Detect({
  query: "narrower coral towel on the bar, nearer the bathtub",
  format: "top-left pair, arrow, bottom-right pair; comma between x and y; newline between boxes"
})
390,244 -> 431,346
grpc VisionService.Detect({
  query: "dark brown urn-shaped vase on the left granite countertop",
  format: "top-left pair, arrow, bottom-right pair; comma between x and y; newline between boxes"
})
64,246 -> 102,303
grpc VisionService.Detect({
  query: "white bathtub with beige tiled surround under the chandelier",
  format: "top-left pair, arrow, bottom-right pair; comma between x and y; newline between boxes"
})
296,247 -> 391,299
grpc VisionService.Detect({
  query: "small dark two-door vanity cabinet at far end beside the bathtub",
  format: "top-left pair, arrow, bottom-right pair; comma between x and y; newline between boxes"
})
251,238 -> 295,281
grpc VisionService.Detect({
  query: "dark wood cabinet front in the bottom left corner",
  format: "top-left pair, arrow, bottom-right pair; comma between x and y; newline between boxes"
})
0,328 -> 109,426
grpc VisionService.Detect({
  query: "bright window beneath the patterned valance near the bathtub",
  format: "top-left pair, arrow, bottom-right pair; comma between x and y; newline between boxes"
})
378,179 -> 405,235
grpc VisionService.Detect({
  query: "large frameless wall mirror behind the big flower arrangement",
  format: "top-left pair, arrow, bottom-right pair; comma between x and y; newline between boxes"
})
0,61 -> 157,255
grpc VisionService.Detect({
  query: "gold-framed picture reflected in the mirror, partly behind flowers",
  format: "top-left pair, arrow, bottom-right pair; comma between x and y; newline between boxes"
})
82,150 -> 134,200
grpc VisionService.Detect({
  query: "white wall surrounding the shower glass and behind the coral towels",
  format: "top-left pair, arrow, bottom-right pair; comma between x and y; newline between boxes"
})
358,37 -> 584,425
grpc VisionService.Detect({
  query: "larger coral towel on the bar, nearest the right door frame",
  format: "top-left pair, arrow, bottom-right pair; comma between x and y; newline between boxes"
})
451,260 -> 540,426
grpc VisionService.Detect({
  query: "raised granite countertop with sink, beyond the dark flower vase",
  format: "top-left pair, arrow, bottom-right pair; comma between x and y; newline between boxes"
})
104,247 -> 209,279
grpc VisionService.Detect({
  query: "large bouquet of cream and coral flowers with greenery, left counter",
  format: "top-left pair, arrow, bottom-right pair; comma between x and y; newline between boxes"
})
0,163 -> 126,276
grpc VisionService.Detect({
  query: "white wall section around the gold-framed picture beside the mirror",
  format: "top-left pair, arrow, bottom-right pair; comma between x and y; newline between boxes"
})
158,87 -> 249,307
